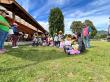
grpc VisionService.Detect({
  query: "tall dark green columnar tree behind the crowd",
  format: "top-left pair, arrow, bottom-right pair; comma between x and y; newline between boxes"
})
48,8 -> 64,36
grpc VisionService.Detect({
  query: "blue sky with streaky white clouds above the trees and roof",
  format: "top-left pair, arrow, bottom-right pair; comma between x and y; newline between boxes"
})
17,0 -> 110,33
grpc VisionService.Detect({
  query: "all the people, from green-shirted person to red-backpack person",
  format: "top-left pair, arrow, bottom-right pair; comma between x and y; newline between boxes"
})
0,6 -> 92,54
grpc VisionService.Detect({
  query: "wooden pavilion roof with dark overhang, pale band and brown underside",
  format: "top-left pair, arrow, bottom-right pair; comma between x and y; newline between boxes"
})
0,0 -> 47,35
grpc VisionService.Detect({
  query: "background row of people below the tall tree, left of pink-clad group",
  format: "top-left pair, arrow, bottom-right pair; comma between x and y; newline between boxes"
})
32,31 -> 64,47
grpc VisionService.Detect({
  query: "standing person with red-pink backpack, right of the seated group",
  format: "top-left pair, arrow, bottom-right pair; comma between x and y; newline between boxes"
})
83,24 -> 92,48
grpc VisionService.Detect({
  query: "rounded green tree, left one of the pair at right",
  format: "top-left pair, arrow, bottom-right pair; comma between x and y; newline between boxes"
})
70,21 -> 83,33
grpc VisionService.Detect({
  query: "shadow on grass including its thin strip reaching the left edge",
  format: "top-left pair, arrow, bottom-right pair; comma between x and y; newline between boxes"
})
0,46 -> 88,72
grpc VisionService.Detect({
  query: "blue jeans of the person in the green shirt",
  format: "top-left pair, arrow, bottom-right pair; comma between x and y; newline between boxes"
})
0,29 -> 8,49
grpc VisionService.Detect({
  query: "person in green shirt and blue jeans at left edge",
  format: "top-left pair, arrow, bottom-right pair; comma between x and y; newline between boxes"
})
0,6 -> 10,54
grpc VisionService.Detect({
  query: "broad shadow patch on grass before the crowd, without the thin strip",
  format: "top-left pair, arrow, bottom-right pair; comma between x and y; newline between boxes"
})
8,46 -> 66,62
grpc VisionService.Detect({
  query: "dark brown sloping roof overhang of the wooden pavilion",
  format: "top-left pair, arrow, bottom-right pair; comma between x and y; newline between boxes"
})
0,0 -> 47,33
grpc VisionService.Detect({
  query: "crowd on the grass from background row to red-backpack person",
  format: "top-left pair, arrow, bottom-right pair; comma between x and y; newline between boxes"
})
32,24 -> 92,55
